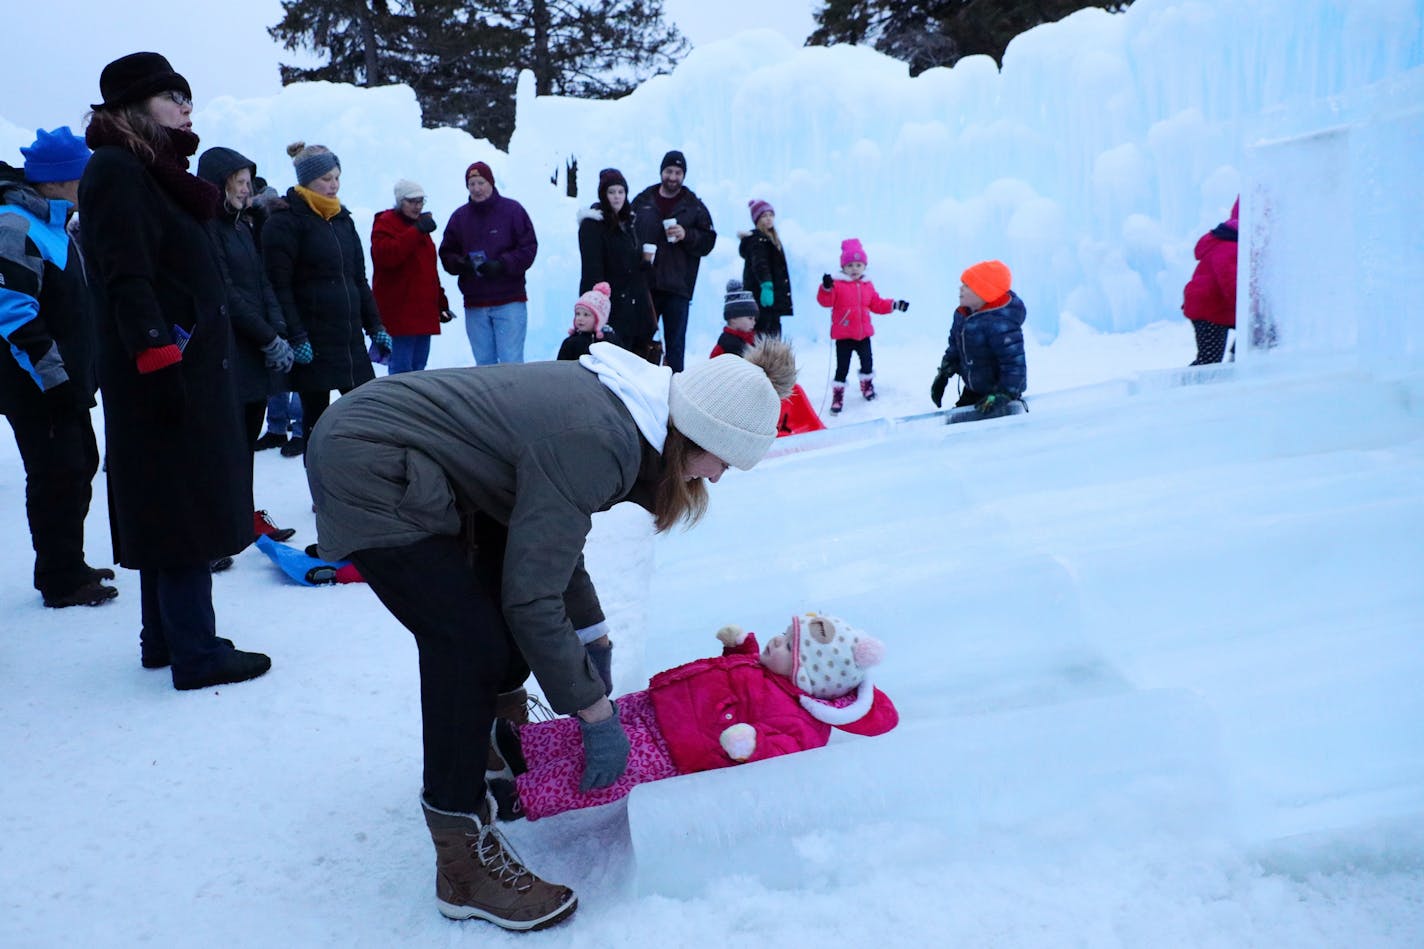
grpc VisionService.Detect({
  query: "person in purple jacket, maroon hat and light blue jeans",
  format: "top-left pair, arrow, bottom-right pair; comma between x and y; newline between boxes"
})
440,161 -> 538,366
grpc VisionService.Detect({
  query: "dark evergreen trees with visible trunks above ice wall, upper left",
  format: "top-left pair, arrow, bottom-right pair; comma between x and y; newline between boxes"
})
269,0 -> 686,148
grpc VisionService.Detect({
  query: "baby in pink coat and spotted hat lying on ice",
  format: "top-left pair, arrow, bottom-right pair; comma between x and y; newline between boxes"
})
501,613 -> 900,821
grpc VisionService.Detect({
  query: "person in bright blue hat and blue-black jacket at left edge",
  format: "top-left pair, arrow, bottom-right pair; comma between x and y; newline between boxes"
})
0,127 -> 118,607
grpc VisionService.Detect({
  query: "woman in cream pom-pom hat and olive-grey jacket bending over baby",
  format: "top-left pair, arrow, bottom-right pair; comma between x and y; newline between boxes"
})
306,341 -> 796,929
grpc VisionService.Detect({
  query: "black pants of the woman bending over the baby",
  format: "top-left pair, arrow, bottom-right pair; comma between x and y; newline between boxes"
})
352,536 -> 530,814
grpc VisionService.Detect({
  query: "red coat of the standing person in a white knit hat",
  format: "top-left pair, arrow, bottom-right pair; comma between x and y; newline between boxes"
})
370,208 -> 450,336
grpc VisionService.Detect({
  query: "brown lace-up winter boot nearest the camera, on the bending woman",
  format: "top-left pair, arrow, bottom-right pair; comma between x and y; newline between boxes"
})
420,795 -> 578,930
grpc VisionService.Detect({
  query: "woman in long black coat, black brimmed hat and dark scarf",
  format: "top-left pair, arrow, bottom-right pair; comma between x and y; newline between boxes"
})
80,53 -> 272,688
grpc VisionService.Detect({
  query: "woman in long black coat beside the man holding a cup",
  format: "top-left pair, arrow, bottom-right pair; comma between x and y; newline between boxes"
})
578,168 -> 658,365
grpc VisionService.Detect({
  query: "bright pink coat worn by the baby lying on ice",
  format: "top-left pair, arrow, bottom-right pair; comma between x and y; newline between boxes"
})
648,633 -> 900,774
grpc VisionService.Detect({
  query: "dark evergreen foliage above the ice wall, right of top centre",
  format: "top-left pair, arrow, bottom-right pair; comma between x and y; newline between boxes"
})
806,0 -> 1132,76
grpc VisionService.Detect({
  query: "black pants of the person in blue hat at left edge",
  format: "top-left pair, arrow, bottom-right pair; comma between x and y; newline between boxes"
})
6,406 -> 98,597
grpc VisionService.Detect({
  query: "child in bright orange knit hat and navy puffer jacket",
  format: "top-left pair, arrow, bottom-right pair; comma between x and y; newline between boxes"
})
930,261 -> 1028,422
